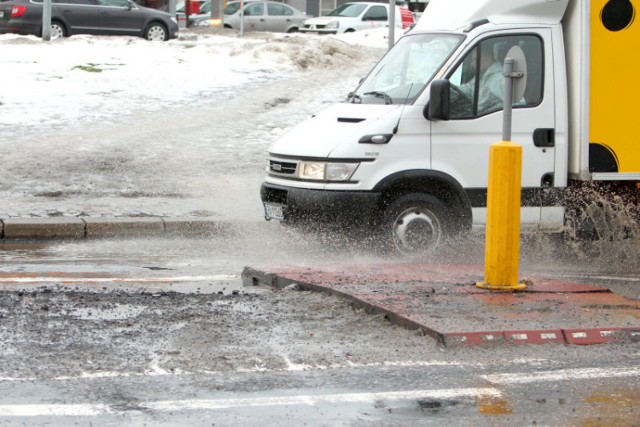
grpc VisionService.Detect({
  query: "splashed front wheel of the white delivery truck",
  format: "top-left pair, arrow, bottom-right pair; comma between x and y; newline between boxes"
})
382,193 -> 450,256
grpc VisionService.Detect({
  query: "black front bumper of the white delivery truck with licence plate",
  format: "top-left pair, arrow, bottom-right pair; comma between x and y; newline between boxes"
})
260,183 -> 380,225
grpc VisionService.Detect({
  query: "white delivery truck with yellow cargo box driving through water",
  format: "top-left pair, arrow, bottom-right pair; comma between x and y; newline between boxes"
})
261,0 -> 640,254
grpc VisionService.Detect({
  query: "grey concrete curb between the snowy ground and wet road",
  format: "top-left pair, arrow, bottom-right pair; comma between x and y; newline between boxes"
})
0,217 -> 239,240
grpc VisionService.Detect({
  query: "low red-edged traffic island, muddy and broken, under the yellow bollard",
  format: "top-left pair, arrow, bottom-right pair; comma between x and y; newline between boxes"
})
242,264 -> 640,348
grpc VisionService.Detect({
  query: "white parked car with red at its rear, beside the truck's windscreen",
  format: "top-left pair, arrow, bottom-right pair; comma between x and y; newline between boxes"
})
300,2 -> 414,34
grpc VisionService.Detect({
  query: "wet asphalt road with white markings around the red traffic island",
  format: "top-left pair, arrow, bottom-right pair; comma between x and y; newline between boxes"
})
0,236 -> 640,426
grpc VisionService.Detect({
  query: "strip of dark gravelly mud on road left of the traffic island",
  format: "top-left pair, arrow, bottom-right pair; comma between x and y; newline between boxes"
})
0,287 -> 438,379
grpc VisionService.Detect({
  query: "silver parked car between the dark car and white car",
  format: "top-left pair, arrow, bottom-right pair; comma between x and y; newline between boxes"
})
224,1 -> 309,33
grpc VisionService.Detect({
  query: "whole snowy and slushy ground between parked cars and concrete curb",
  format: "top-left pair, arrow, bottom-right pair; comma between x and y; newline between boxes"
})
0,31 -> 387,221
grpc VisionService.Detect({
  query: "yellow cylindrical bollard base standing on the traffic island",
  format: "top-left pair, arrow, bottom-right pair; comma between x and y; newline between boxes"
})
476,141 -> 526,291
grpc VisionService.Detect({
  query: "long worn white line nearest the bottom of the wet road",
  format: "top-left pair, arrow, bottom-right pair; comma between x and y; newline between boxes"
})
0,388 -> 502,417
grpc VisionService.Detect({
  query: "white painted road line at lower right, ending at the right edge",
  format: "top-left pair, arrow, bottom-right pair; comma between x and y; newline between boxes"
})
482,368 -> 640,384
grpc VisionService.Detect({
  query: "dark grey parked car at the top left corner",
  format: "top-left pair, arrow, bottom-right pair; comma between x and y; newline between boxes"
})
0,0 -> 178,41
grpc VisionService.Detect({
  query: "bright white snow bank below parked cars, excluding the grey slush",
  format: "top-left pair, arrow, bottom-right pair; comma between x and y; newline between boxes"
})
0,28 -> 387,129
